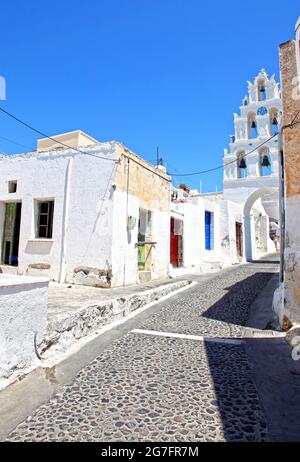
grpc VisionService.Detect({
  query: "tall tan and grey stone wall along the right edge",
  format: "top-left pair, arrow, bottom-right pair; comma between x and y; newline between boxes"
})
278,28 -> 300,326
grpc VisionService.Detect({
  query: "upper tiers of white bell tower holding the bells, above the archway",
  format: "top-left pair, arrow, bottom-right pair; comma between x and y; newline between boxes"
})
224,69 -> 281,200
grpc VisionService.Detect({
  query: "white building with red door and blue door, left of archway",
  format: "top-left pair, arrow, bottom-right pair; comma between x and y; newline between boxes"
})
170,184 -> 244,275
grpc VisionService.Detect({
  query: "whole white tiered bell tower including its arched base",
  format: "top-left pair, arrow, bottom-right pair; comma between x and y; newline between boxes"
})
223,69 -> 282,260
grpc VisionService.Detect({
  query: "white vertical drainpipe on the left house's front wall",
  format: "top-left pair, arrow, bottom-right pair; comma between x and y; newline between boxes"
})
58,157 -> 73,284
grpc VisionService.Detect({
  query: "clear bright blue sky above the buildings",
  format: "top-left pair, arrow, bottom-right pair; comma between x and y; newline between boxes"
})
0,0 -> 300,191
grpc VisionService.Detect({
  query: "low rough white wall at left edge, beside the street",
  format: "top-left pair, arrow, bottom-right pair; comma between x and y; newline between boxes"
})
0,275 -> 48,389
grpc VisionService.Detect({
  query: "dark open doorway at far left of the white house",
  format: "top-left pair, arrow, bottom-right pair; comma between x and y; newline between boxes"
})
1,202 -> 22,266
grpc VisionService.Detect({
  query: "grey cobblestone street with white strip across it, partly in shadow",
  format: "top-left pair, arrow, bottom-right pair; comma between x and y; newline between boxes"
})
7,261 -> 278,442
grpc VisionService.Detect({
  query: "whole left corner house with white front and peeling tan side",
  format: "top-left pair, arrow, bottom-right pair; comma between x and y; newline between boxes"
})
0,131 -> 170,287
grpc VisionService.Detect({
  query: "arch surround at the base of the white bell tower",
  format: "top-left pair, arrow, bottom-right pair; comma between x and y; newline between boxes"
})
244,188 -> 279,261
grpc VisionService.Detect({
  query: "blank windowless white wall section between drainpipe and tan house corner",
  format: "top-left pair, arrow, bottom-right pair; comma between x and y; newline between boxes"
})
62,143 -> 115,281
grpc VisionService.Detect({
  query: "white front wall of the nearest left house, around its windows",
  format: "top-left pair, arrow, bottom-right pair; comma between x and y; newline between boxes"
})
0,143 -> 115,282
